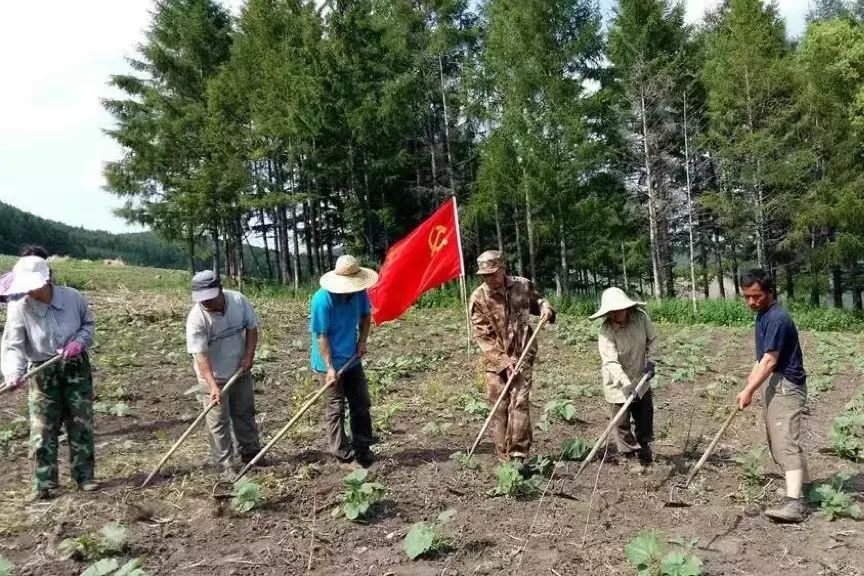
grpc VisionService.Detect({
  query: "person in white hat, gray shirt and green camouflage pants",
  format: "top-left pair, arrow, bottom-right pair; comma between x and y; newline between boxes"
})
2,256 -> 99,499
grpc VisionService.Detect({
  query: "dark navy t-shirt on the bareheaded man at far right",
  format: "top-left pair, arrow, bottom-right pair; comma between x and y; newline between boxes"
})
756,302 -> 807,386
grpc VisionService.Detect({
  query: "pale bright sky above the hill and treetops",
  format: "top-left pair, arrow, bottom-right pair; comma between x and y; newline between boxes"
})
0,0 -> 808,232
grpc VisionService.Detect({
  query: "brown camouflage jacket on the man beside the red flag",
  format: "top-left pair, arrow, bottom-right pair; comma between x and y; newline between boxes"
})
468,276 -> 555,373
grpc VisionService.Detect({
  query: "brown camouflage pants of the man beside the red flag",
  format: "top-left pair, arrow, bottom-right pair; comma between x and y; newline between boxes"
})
486,366 -> 533,461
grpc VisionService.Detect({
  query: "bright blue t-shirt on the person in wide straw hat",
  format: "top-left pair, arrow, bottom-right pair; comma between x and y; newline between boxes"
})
309,288 -> 372,372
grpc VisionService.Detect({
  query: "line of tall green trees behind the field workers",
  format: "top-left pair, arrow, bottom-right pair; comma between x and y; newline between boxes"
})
104,0 -> 864,309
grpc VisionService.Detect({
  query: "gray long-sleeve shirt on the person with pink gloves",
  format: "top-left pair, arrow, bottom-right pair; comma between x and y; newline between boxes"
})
0,285 -> 95,381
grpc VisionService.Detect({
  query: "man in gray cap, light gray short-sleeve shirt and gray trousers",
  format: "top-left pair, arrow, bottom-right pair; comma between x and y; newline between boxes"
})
186,270 -> 266,479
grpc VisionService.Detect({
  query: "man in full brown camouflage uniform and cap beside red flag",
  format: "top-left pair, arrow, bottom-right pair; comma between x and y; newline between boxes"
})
468,250 -> 555,462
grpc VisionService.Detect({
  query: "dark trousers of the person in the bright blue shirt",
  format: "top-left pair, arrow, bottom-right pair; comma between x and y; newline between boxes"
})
318,363 -> 372,457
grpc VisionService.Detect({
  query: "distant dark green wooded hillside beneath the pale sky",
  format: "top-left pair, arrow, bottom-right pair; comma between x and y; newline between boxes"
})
0,202 -> 187,269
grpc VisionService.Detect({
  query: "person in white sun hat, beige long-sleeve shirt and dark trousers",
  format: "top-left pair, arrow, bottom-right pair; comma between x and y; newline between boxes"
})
591,288 -> 660,470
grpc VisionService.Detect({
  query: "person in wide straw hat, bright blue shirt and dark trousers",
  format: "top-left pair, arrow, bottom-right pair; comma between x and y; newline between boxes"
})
309,254 -> 378,467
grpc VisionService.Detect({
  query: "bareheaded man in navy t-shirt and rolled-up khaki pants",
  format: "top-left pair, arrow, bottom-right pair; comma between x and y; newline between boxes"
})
736,269 -> 807,522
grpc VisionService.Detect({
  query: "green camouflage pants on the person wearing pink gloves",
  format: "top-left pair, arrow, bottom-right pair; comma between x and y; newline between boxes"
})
28,354 -> 95,490
